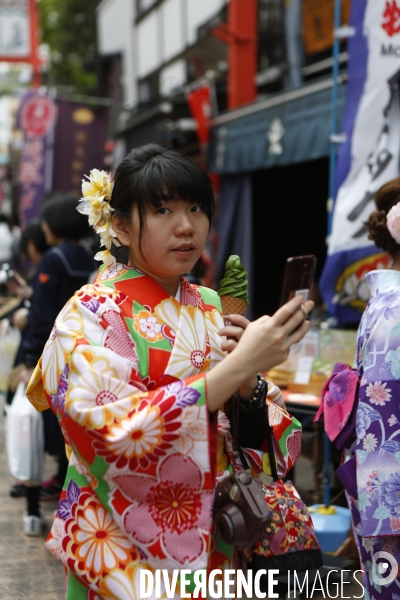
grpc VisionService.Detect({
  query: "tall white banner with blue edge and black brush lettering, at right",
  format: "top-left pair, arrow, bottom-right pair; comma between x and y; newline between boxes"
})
320,0 -> 400,324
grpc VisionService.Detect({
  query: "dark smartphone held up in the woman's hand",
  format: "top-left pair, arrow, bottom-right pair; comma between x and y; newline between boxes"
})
279,254 -> 317,306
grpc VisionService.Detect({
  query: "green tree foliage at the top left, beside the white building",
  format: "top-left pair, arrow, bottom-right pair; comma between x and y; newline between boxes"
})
39,0 -> 98,94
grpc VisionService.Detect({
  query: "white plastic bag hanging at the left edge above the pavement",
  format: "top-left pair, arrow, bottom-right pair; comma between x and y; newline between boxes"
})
6,382 -> 44,485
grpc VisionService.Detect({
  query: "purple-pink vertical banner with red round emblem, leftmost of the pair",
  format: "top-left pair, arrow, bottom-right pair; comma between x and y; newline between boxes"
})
18,91 -> 56,227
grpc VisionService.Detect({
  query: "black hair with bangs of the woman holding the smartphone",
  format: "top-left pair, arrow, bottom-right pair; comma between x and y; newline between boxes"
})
110,144 -> 214,235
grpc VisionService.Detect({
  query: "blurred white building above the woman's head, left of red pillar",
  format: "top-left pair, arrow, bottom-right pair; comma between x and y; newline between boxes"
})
97,0 -> 227,160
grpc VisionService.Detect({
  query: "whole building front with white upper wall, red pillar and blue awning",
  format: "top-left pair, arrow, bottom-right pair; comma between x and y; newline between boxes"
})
97,0 -> 350,316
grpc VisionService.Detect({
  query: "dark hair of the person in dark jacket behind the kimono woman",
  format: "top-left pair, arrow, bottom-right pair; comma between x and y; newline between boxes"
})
40,194 -> 91,240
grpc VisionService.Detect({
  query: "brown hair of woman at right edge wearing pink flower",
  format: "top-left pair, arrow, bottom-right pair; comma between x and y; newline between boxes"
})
365,177 -> 400,256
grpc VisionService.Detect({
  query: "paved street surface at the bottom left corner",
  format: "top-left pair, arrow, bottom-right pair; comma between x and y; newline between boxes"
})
0,396 -> 64,600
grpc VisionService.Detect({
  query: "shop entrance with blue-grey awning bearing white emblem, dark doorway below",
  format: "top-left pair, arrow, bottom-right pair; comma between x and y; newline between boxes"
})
208,79 -> 345,316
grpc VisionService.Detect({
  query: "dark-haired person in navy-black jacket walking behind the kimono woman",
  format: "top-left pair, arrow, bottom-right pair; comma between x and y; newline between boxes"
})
15,195 -> 97,535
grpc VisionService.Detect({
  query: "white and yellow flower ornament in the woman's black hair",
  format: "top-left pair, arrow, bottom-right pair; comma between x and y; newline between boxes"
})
76,169 -> 121,265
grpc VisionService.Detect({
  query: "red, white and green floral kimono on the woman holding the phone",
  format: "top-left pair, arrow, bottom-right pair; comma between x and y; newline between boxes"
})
27,264 -> 290,600
